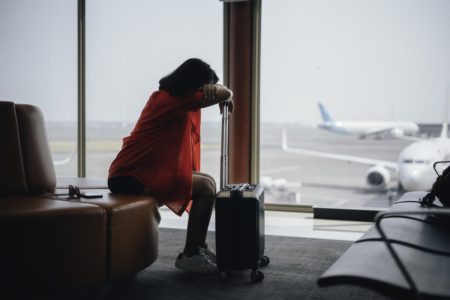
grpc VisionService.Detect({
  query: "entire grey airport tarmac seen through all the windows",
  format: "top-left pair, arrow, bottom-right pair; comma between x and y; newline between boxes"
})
49,124 -> 438,207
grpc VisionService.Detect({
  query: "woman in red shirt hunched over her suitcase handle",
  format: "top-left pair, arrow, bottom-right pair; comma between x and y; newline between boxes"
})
108,58 -> 233,273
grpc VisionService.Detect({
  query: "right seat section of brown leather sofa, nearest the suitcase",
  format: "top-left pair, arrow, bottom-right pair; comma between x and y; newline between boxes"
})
57,189 -> 161,279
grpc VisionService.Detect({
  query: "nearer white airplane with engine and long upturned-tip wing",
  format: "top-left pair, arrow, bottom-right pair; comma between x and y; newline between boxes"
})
282,103 -> 450,191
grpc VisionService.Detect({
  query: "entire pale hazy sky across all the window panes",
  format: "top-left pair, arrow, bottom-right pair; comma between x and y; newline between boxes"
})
0,0 -> 450,125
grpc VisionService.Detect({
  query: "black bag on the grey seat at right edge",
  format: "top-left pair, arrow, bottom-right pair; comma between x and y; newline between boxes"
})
420,161 -> 450,207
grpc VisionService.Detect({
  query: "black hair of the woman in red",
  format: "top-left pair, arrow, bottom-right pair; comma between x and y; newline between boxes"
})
159,58 -> 219,97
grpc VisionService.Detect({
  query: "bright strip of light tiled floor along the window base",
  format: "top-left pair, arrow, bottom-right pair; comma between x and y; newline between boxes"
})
160,207 -> 372,241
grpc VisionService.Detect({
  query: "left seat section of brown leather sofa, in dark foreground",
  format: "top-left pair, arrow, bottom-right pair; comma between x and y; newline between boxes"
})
0,196 -> 107,295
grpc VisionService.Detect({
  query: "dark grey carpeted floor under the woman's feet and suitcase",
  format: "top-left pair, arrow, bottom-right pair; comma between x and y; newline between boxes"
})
40,228 -> 388,300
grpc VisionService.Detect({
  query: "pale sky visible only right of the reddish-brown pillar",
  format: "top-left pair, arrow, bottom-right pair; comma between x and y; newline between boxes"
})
261,0 -> 450,123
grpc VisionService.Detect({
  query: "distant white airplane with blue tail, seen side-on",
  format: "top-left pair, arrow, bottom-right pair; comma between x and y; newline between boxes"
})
319,102 -> 419,140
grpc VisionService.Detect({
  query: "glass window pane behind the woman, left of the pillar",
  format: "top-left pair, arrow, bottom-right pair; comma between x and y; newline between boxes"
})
86,0 -> 223,182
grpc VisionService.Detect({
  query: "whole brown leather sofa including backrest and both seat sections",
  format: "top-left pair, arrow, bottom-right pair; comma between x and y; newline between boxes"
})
0,101 -> 160,297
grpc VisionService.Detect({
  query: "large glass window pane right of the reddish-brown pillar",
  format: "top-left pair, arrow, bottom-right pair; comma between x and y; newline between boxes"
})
261,0 -> 450,207
